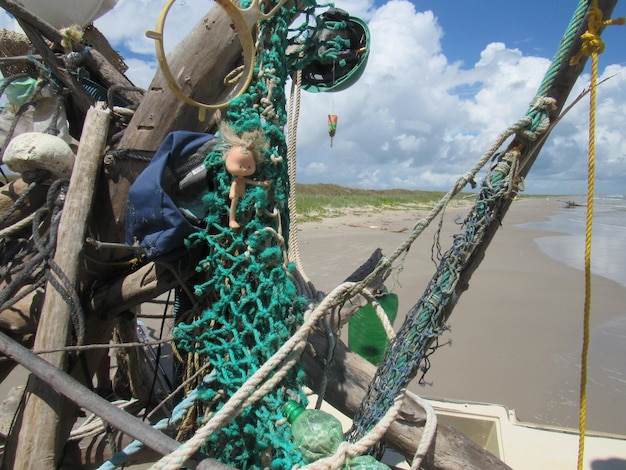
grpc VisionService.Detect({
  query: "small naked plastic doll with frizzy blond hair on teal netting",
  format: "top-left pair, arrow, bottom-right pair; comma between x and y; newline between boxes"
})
220,124 -> 270,228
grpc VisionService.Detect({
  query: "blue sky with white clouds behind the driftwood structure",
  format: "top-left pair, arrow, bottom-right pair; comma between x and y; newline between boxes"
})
0,0 -> 626,195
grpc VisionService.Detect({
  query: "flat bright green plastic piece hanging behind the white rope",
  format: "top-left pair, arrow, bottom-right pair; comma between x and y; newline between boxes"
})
348,294 -> 398,365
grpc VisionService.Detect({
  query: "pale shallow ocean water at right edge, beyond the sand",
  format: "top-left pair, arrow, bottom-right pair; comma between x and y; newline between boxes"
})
524,194 -> 626,287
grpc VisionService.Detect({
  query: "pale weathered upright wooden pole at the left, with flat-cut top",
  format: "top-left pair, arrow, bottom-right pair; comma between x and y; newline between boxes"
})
5,103 -> 110,470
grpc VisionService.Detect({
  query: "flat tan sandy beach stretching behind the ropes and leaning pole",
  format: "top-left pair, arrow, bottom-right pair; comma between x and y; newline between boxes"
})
298,198 -> 626,434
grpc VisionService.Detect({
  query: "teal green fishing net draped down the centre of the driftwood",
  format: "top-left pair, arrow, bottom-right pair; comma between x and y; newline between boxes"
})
168,2 -> 344,469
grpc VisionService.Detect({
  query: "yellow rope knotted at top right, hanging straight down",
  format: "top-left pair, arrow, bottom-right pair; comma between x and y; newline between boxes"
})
570,0 -> 624,470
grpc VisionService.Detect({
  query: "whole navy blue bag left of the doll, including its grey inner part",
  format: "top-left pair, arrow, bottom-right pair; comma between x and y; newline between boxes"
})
126,131 -> 217,261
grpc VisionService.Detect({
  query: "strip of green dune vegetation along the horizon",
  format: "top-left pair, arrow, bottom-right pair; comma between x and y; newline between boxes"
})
296,184 -> 467,222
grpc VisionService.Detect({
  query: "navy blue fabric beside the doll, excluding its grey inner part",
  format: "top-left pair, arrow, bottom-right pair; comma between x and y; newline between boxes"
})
126,131 -> 215,261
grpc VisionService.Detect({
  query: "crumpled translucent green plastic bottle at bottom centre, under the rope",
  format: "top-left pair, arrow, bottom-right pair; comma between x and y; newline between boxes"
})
283,400 -> 390,470
